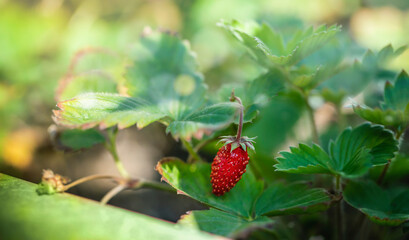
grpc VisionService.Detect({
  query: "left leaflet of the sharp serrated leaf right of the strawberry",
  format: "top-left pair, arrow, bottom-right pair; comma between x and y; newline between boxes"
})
274,144 -> 331,174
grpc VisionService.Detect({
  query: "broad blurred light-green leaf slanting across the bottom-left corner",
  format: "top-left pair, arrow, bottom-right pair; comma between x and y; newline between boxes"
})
0,174 -> 215,240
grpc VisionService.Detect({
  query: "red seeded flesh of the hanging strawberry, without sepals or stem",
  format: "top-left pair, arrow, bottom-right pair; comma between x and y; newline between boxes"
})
210,143 -> 249,196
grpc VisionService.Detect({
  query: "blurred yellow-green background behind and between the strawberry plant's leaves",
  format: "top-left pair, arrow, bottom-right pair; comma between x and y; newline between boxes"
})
0,0 -> 409,221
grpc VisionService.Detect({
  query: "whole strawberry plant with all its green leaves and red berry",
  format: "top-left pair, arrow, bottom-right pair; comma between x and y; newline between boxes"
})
0,18 -> 409,239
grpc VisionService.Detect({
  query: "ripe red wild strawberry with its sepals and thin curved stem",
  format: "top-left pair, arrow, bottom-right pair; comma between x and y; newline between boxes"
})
210,92 -> 254,196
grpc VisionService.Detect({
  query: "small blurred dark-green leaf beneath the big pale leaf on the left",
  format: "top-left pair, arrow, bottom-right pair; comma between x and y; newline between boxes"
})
60,128 -> 105,150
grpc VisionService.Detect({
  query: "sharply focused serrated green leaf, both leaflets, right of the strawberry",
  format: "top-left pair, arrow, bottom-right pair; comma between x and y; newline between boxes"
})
275,123 -> 398,178
